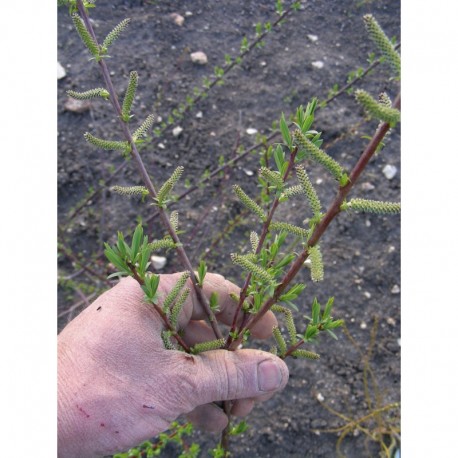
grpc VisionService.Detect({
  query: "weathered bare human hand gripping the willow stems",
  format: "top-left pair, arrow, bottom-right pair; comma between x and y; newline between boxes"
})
58,274 -> 288,458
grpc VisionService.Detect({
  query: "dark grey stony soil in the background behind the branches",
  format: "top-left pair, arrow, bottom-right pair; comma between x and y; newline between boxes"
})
58,0 -> 400,457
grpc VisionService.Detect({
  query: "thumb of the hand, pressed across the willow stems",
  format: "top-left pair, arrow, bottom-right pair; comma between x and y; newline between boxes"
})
187,349 -> 289,406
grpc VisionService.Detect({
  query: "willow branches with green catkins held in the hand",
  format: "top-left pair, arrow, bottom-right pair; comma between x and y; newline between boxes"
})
61,0 -> 400,456
